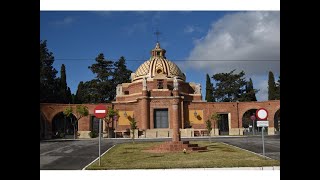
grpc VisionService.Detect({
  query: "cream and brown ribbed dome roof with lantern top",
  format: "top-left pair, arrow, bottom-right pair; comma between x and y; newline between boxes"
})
133,43 -> 186,81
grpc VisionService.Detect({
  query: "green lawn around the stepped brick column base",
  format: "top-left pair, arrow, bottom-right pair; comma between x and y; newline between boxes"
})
86,141 -> 280,169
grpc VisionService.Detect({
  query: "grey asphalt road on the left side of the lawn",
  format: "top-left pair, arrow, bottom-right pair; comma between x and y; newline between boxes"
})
40,139 -> 113,170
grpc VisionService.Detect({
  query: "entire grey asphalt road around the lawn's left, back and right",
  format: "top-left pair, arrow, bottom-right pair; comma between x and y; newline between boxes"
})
40,135 -> 280,170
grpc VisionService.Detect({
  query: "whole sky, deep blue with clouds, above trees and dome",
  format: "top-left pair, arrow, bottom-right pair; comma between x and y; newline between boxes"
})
40,10 -> 280,101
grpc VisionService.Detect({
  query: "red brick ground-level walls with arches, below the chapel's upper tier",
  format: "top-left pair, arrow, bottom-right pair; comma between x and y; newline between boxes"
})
40,98 -> 280,136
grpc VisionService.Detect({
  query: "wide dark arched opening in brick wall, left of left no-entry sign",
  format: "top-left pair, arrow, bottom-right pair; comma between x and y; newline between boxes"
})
52,112 -> 78,139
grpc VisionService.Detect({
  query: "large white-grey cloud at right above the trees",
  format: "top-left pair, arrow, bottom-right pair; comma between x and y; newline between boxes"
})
187,11 -> 280,75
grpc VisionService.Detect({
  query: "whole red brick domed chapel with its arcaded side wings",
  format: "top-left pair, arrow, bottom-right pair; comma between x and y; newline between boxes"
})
40,44 -> 280,141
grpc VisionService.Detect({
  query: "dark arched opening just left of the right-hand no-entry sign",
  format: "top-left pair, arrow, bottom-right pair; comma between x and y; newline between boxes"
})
242,109 -> 258,135
